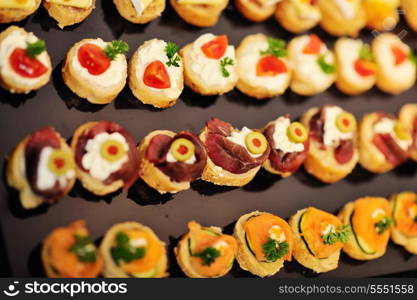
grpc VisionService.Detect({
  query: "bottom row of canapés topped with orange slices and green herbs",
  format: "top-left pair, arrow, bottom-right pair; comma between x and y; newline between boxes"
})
42,192 -> 417,278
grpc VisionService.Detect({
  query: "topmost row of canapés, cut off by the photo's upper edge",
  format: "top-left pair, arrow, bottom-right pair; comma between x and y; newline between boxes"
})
0,0 -> 417,37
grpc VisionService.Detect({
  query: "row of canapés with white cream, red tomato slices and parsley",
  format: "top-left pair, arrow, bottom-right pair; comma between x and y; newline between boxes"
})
0,26 -> 417,108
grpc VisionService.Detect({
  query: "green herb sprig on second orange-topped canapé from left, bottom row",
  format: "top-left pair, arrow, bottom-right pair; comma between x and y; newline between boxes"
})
111,231 -> 146,263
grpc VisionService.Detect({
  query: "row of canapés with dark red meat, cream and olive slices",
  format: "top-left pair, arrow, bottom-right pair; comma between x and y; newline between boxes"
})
7,104 -> 417,209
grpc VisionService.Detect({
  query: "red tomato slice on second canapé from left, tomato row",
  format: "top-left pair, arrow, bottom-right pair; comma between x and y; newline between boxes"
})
78,43 -> 111,75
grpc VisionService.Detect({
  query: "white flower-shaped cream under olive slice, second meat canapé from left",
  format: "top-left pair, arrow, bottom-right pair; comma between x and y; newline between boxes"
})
81,132 -> 129,181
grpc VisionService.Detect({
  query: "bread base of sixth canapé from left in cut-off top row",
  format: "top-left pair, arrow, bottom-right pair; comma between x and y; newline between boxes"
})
275,0 -> 321,34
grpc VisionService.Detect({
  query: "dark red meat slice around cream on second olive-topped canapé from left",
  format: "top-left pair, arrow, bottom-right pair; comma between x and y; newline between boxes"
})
75,121 -> 139,190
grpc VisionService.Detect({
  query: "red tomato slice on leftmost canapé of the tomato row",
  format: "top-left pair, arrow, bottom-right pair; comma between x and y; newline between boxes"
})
9,48 -> 48,78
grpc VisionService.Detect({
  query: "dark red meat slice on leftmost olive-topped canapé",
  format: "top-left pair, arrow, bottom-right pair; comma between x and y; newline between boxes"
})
25,127 -> 64,201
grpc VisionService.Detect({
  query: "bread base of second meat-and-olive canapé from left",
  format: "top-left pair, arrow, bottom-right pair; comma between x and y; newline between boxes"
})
71,122 -> 124,196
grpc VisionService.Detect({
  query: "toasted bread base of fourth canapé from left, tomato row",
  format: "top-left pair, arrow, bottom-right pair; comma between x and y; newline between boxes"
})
180,38 -> 238,96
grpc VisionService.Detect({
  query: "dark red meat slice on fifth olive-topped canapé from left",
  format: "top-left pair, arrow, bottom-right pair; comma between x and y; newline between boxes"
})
263,124 -> 310,173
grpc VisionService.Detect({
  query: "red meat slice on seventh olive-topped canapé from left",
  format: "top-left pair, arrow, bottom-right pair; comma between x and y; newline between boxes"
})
372,113 -> 409,166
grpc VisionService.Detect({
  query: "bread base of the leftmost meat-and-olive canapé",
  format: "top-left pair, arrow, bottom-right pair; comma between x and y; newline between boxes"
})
6,127 -> 76,209
